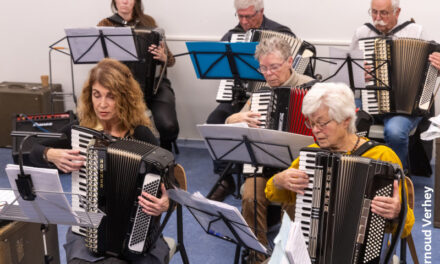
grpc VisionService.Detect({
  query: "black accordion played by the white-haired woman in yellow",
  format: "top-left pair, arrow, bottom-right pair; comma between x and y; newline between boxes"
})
294,148 -> 399,264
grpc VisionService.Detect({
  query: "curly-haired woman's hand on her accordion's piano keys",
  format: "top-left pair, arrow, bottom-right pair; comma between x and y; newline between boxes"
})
46,148 -> 85,173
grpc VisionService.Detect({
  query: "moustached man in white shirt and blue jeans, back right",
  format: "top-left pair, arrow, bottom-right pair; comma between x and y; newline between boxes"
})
351,0 -> 434,169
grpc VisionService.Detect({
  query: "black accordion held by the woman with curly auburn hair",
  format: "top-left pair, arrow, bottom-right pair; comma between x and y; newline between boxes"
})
72,126 -> 174,256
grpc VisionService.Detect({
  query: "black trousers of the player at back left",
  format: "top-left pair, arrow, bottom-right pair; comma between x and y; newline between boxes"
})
145,78 -> 179,150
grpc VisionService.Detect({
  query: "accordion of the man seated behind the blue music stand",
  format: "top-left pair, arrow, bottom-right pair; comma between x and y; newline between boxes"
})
216,29 -> 316,102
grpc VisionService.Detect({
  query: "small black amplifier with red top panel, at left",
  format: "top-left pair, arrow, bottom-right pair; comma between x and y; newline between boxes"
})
12,111 -> 76,166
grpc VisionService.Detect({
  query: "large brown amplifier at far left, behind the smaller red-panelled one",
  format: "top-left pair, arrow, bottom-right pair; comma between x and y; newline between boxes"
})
0,82 -> 64,147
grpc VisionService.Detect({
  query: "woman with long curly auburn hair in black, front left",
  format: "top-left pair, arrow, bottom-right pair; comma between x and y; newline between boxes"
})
30,59 -> 169,263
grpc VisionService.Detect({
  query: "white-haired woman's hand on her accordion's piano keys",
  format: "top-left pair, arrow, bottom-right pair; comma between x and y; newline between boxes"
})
273,169 -> 309,194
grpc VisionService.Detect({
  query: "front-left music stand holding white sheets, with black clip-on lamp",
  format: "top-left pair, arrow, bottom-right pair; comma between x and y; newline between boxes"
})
0,131 -> 105,264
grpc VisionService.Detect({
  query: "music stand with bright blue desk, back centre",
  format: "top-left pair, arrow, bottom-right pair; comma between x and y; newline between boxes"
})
186,42 -> 264,104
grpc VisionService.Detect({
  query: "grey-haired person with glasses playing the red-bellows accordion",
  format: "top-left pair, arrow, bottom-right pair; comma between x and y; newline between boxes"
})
226,37 -> 313,260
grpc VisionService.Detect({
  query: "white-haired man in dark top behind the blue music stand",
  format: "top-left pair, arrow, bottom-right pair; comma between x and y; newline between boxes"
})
206,0 -> 295,201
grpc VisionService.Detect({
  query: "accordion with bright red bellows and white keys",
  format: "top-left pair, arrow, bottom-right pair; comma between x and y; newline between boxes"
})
251,85 -> 314,136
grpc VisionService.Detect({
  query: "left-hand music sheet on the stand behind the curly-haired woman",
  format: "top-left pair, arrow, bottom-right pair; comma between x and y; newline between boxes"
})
64,27 -> 104,63
